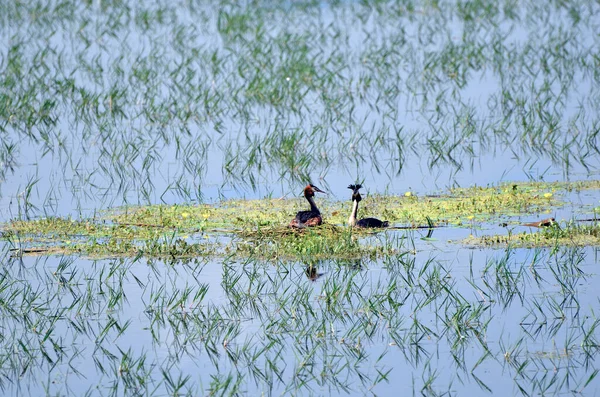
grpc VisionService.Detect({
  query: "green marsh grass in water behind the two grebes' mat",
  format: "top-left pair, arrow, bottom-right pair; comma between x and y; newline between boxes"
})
0,1 -> 600,218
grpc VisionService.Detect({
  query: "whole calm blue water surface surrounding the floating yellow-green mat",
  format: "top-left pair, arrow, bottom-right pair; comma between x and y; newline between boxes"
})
0,0 -> 600,395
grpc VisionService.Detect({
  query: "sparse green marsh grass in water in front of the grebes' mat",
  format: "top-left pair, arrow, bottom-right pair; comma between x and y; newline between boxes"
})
0,237 -> 598,394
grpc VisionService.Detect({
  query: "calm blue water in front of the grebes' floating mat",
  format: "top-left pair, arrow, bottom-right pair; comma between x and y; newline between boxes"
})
2,244 -> 599,395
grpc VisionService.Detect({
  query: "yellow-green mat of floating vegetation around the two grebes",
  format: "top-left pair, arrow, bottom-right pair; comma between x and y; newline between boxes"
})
1,181 -> 600,259
